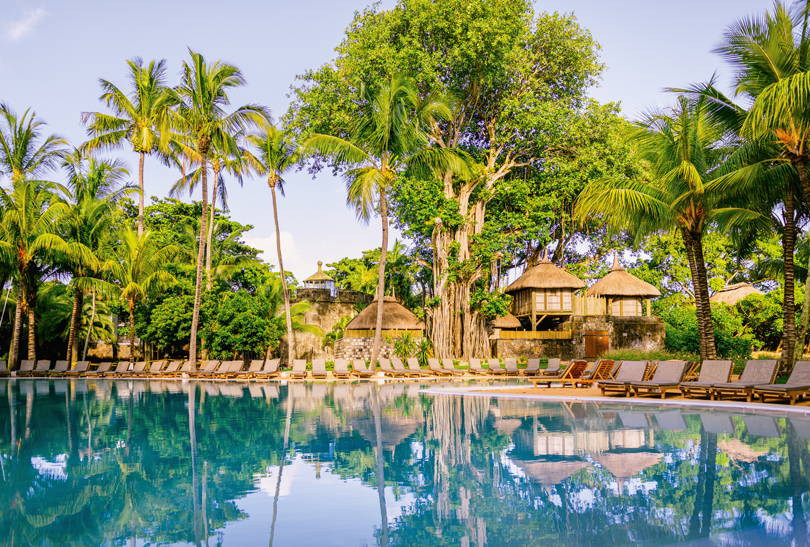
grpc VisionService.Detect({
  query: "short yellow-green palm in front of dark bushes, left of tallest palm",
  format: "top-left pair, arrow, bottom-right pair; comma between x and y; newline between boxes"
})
74,230 -> 178,359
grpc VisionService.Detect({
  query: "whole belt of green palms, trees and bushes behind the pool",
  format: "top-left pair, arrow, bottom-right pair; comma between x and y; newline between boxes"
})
0,0 -> 810,367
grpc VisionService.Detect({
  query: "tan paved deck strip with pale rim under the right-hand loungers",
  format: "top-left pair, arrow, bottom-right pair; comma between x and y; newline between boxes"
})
421,386 -> 810,415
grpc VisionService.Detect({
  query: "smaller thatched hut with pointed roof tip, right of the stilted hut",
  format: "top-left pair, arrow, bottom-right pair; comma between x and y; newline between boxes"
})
586,254 -> 661,317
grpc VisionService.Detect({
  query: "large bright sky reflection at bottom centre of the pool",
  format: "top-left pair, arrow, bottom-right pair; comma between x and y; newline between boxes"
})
218,455 -> 414,547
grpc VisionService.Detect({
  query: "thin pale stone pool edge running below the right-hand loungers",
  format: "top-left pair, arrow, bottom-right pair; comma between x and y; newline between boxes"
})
419,387 -> 810,416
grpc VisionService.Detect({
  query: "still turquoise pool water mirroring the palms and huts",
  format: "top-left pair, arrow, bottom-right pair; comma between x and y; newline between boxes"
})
0,379 -> 810,547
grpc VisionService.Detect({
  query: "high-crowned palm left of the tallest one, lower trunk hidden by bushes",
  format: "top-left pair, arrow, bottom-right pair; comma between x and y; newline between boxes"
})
82,57 -> 174,234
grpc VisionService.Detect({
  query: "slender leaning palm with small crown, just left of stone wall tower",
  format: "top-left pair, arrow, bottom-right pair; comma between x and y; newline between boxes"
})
246,123 -> 299,364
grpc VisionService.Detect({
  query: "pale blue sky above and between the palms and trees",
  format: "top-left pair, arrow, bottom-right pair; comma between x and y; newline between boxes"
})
0,0 -> 772,280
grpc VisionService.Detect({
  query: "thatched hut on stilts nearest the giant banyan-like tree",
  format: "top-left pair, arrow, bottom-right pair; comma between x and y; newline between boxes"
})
505,251 -> 586,331
